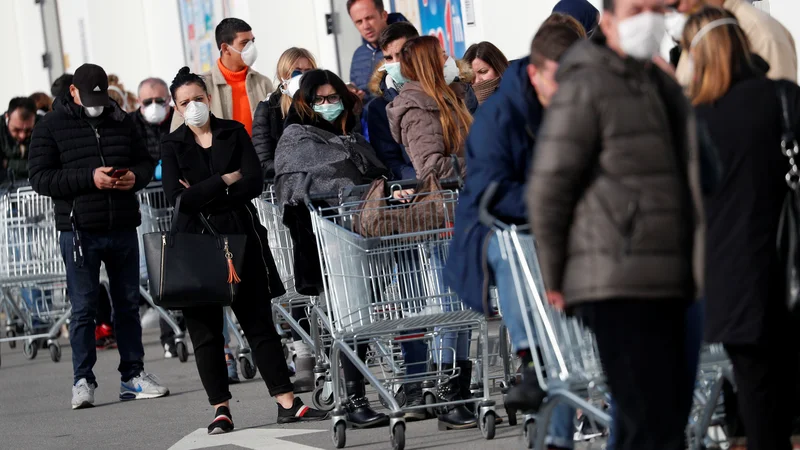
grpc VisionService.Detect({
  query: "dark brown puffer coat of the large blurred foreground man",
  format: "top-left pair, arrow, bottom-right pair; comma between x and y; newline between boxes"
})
527,41 -> 705,306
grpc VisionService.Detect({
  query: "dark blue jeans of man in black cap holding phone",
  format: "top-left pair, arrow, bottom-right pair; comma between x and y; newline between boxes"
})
60,230 -> 144,383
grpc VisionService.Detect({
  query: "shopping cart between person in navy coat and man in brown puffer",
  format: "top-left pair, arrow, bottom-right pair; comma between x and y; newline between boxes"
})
480,182 -> 611,450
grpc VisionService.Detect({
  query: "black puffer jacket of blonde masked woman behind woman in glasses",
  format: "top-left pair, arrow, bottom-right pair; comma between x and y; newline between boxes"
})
253,90 -> 283,179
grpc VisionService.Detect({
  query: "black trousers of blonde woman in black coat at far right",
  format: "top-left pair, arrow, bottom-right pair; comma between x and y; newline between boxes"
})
725,333 -> 798,450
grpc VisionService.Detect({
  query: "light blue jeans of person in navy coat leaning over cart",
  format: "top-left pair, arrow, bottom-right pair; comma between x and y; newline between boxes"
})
486,235 -> 576,448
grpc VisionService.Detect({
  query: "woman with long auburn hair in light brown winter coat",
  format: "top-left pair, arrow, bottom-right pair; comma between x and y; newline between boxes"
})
386,36 -> 476,429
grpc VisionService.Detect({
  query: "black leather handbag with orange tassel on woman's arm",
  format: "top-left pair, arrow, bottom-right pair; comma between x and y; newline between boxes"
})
144,197 -> 247,309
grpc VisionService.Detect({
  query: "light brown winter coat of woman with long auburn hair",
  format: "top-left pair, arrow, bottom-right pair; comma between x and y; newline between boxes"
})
386,81 -> 467,178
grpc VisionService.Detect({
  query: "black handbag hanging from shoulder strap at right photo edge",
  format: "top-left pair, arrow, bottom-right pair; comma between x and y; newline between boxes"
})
777,85 -> 800,324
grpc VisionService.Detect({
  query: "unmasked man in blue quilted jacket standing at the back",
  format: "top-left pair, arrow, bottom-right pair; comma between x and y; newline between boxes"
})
347,0 -> 407,105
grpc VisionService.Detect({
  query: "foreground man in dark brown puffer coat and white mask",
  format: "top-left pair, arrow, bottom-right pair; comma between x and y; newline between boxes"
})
526,0 -> 704,450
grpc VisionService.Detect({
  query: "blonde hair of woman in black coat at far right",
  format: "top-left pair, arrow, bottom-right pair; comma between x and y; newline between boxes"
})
681,6 -> 752,105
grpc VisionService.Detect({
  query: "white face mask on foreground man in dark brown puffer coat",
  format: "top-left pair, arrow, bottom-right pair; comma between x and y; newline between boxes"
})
617,11 -> 667,60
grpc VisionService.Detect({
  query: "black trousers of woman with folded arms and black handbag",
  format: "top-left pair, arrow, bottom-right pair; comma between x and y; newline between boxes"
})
183,295 -> 294,405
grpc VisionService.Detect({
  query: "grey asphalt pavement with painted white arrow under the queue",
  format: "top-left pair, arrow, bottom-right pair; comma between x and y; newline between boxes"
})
0,330 -> 601,450
